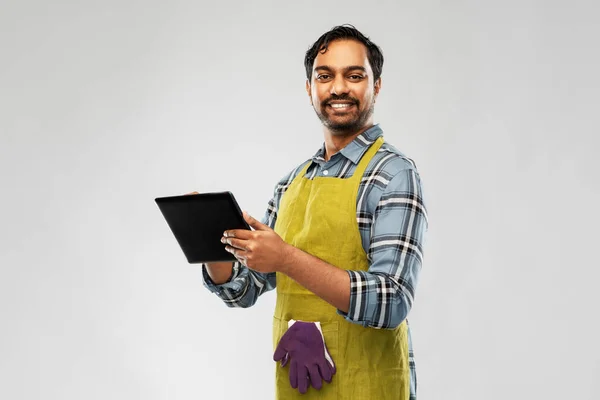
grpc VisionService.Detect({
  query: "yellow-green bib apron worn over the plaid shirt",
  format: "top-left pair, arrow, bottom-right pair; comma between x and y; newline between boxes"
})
273,137 -> 410,400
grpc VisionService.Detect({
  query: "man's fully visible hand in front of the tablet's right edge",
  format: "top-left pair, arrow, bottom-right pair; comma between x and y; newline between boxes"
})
221,212 -> 292,273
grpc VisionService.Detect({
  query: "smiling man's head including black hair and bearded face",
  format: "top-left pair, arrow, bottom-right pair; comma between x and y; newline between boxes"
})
304,25 -> 383,135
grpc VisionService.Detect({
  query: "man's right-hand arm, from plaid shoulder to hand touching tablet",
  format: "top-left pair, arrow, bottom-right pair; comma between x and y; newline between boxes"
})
223,170 -> 427,329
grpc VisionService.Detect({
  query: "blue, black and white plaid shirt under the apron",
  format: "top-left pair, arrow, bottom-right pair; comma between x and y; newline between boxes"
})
203,125 -> 428,399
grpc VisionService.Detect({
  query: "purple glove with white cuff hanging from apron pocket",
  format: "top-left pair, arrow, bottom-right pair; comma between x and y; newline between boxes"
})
273,321 -> 335,394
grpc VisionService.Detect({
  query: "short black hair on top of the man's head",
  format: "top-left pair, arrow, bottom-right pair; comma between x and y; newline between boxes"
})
304,24 -> 383,81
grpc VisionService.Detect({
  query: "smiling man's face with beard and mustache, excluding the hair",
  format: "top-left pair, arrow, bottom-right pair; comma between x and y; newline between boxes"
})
306,40 -> 381,135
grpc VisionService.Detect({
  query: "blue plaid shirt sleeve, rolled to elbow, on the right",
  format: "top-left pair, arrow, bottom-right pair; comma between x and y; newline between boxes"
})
338,169 -> 428,329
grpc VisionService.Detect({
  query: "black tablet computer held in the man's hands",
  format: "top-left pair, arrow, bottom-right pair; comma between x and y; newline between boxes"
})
154,192 -> 251,264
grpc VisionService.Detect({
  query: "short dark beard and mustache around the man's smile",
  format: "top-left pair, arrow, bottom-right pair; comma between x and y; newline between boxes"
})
313,96 -> 375,136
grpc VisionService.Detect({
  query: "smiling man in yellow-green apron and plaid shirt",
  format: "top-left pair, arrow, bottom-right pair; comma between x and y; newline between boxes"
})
203,26 -> 428,400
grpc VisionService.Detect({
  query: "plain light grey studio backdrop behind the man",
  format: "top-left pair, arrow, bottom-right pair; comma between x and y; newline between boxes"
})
0,0 -> 600,400
